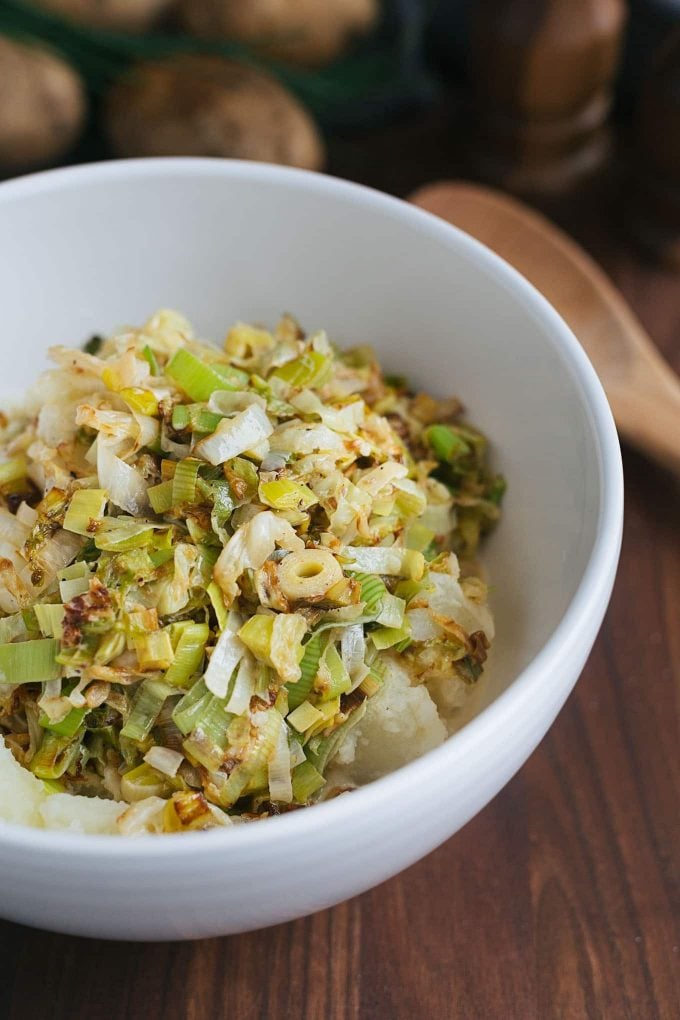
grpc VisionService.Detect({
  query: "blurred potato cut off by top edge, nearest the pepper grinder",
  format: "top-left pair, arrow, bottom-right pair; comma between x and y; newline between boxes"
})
179,0 -> 379,67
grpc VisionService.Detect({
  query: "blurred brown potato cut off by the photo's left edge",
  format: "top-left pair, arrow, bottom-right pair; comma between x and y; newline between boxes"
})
0,37 -> 86,171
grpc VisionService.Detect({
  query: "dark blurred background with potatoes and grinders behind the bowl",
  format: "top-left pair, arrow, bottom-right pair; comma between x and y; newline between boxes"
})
0,0 -> 680,279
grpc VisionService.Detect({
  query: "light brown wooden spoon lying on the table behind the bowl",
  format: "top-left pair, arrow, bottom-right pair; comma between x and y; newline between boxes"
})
411,182 -> 680,473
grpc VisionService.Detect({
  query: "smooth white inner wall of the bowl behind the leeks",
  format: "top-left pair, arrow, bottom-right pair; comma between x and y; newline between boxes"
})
0,161 -> 600,718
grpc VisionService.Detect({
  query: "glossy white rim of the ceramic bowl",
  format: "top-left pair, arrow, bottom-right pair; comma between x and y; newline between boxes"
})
0,157 -> 623,862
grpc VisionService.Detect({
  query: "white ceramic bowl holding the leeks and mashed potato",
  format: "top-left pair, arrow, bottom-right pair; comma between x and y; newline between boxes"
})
0,159 -> 622,939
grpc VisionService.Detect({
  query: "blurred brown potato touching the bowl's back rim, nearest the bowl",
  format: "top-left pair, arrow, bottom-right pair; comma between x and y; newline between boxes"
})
106,55 -> 323,169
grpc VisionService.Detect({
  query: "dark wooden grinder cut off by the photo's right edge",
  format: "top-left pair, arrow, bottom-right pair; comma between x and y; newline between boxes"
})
624,30 -> 680,270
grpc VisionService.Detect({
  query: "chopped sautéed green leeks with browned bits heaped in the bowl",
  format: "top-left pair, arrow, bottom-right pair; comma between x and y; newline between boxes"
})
0,311 -> 505,833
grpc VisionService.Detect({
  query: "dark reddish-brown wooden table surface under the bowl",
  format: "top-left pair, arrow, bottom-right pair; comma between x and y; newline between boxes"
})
0,111 -> 680,1020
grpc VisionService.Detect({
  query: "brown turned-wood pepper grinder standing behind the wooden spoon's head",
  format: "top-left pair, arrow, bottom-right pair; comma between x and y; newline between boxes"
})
471,0 -> 626,195
